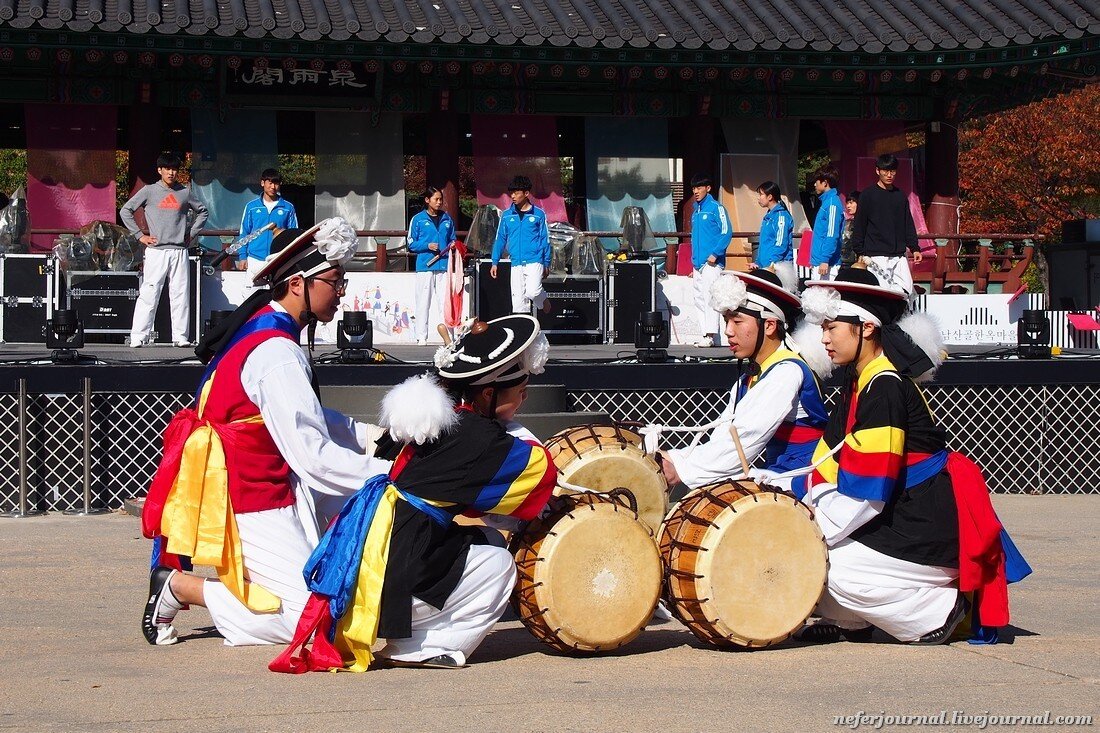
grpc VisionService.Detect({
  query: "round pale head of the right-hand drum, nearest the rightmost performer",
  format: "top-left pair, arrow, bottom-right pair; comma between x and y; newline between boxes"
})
696,492 -> 828,646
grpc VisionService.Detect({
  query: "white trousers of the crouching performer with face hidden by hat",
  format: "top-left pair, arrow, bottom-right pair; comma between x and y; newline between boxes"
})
377,539 -> 517,664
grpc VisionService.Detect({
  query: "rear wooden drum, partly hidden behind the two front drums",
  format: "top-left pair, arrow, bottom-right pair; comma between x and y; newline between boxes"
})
546,425 -> 669,534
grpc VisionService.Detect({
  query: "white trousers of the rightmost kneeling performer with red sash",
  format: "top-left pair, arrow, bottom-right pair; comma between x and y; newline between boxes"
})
816,539 -> 959,642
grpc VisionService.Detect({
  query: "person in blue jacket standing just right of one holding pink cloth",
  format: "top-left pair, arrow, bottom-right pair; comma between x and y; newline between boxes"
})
488,176 -> 551,313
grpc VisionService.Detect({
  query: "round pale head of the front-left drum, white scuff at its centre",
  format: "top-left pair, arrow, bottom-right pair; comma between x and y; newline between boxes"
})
532,502 -> 661,652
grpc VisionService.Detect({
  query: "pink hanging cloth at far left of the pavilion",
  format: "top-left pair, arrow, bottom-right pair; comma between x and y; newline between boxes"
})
26,105 -> 118,252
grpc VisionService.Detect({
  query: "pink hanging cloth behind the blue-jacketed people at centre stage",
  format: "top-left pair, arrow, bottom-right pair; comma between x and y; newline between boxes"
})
470,114 -> 569,221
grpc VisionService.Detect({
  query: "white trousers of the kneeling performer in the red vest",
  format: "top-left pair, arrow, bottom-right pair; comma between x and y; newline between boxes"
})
204,505 -> 314,646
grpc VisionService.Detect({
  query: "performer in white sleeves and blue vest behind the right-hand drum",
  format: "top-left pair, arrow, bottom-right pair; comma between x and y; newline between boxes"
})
659,270 -> 831,489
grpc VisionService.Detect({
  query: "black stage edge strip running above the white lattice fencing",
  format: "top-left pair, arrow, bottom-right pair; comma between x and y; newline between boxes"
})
0,343 -> 1100,394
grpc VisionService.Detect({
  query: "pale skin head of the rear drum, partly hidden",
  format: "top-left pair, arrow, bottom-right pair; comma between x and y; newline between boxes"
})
559,444 -> 669,534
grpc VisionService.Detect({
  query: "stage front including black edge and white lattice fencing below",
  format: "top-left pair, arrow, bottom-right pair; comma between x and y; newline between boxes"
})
0,344 -> 1100,513
